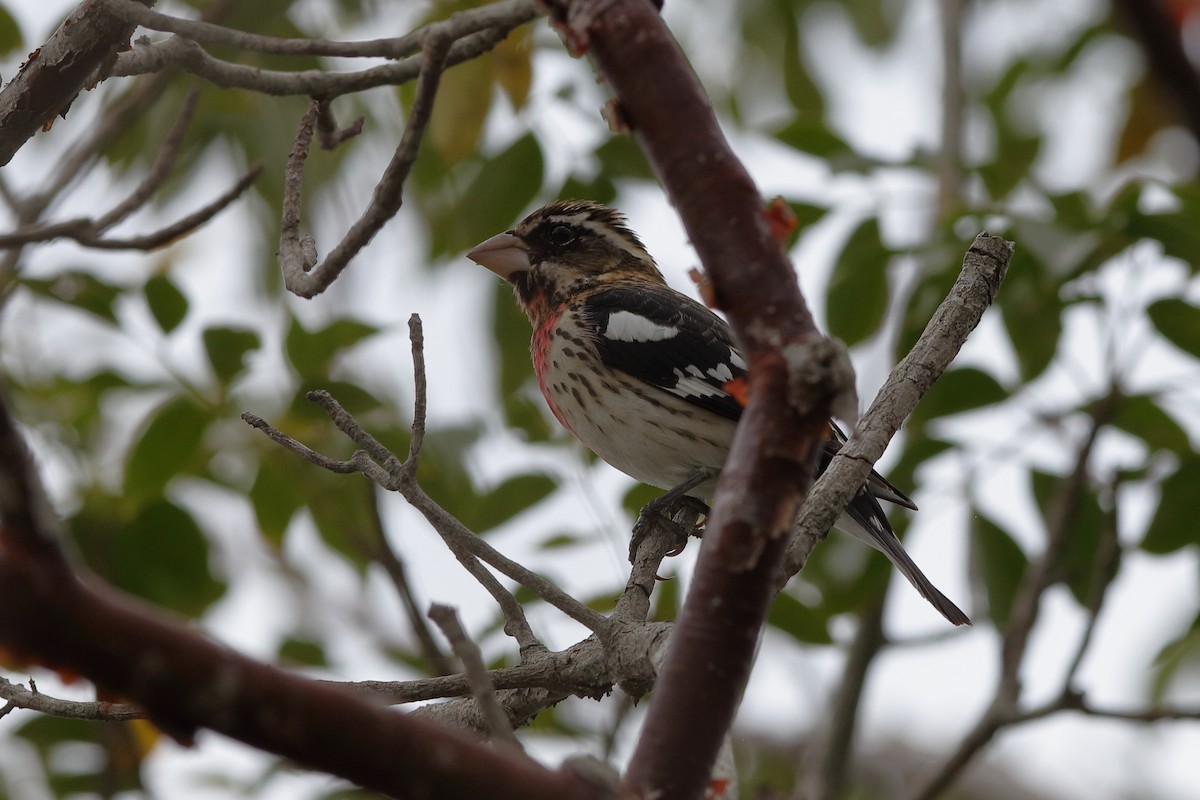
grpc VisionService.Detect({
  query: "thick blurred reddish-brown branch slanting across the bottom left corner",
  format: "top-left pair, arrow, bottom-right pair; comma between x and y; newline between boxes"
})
0,556 -> 604,800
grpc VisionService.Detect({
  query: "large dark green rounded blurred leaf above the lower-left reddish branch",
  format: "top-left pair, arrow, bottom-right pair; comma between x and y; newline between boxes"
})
104,500 -> 224,616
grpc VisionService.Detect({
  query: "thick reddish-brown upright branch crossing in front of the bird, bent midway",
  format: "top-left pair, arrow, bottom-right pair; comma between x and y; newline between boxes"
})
547,0 -> 829,800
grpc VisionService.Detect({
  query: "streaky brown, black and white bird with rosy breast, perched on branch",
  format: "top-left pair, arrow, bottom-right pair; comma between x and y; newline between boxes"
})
467,200 -> 970,625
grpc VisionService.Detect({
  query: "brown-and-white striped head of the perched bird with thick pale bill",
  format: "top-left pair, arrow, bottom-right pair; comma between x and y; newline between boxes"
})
467,200 -> 664,308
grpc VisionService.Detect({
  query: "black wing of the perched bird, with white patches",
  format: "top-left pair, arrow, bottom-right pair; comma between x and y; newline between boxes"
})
583,285 -> 746,421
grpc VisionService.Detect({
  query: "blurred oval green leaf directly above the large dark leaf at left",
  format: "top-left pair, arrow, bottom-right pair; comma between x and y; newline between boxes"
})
125,397 -> 209,497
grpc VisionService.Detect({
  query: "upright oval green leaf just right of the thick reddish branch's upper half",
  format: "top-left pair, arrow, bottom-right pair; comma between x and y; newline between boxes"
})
826,217 -> 890,347
